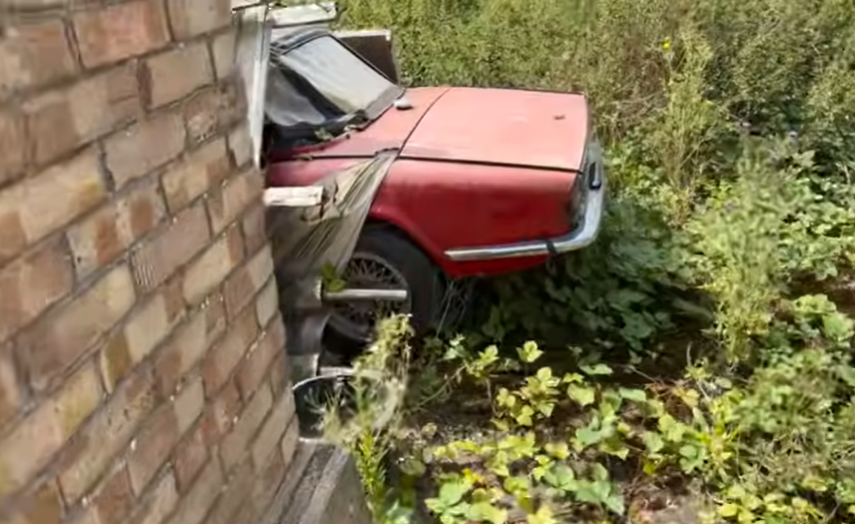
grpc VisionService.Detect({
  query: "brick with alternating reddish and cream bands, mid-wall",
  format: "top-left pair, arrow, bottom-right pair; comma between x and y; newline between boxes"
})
68,179 -> 166,278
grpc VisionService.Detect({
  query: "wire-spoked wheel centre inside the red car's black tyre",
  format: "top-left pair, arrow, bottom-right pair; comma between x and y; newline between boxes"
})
329,251 -> 412,342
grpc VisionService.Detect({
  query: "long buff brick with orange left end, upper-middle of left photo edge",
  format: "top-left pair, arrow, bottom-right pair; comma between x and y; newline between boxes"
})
0,151 -> 107,263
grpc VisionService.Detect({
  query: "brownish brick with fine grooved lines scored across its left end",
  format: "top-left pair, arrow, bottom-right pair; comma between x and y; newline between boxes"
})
131,205 -> 210,291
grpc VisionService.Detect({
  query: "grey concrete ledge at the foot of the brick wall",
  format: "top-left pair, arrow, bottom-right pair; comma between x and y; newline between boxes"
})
260,443 -> 372,524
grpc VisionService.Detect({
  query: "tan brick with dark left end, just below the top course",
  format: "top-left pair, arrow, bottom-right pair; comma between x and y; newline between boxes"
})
143,43 -> 214,107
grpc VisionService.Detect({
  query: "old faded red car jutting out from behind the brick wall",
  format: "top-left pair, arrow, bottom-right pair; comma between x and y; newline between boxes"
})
258,29 -> 605,340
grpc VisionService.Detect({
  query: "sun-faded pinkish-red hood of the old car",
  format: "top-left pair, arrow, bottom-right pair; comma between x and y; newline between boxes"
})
400,88 -> 589,170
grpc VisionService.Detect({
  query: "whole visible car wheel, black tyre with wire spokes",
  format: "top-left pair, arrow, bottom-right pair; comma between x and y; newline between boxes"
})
328,225 -> 446,343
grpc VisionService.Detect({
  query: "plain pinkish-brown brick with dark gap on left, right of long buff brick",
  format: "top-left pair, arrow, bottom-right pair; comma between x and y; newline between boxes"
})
104,113 -> 185,188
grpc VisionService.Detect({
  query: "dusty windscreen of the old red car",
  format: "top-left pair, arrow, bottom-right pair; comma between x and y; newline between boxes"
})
265,35 -> 400,135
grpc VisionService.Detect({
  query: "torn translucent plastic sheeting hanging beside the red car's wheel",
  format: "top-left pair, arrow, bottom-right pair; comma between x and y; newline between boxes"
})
268,151 -> 397,381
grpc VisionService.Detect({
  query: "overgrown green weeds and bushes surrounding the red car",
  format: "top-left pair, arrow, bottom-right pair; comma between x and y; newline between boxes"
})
318,0 -> 855,524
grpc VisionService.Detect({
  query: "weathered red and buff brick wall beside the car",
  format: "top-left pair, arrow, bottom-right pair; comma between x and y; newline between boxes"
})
0,0 -> 297,524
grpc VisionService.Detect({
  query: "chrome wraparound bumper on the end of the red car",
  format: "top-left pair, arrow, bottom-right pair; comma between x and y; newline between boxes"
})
445,168 -> 606,262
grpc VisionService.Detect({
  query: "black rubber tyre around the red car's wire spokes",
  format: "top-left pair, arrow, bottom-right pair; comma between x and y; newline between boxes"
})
327,224 -> 445,343
